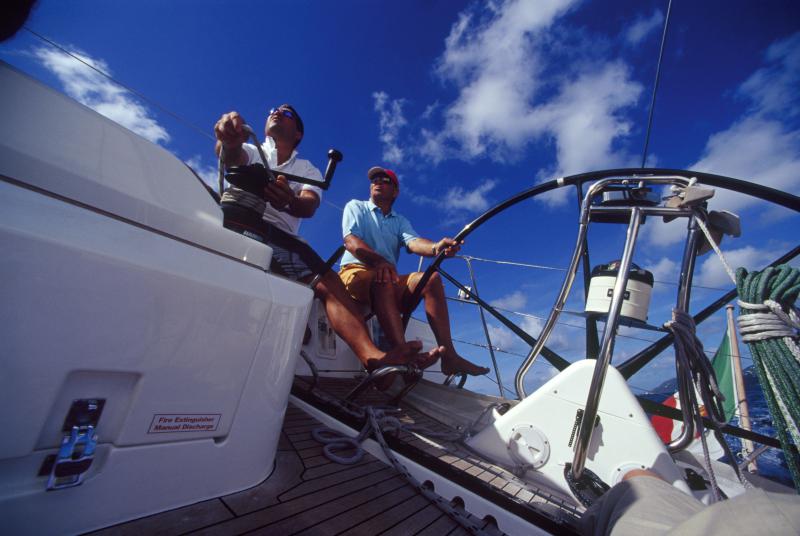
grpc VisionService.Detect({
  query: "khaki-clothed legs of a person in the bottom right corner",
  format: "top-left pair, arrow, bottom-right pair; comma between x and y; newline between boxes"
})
580,469 -> 800,536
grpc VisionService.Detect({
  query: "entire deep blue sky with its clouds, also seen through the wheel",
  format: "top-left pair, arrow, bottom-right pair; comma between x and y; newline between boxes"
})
0,0 -> 800,393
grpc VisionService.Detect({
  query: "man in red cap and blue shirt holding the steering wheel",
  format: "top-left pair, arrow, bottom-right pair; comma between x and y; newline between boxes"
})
339,167 -> 489,376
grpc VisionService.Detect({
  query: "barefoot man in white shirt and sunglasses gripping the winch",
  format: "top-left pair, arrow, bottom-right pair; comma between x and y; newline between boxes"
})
214,104 -> 443,370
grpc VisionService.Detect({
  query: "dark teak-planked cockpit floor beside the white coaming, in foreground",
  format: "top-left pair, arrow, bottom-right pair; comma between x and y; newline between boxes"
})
87,396 -> 500,536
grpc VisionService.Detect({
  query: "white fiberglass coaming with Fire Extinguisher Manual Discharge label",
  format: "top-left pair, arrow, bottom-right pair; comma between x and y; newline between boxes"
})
0,60 -> 312,534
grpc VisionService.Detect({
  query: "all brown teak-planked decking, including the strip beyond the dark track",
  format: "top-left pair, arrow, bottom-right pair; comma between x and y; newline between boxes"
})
100,378 -> 572,536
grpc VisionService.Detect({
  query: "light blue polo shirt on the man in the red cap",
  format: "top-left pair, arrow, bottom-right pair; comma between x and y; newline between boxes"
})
340,199 -> 419,266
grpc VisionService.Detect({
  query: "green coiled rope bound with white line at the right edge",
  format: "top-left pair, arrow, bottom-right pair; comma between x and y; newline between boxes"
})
736,264 -> 800,490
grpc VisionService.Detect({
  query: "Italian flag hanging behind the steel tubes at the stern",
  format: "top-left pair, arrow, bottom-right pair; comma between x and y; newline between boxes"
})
650,330 -> 739,450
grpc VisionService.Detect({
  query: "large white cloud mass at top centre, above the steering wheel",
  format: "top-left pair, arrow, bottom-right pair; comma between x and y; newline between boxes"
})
380,0 -> 642,203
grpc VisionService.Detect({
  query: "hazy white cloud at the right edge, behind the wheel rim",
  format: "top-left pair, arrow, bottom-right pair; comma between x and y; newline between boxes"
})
646,33 -> 800,244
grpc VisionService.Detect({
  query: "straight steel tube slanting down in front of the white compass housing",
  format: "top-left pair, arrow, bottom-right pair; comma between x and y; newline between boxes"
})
572,205 -> 642,480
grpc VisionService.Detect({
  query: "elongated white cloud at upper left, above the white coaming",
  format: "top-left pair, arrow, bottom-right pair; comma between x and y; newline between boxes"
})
33,48 -> 170,143
